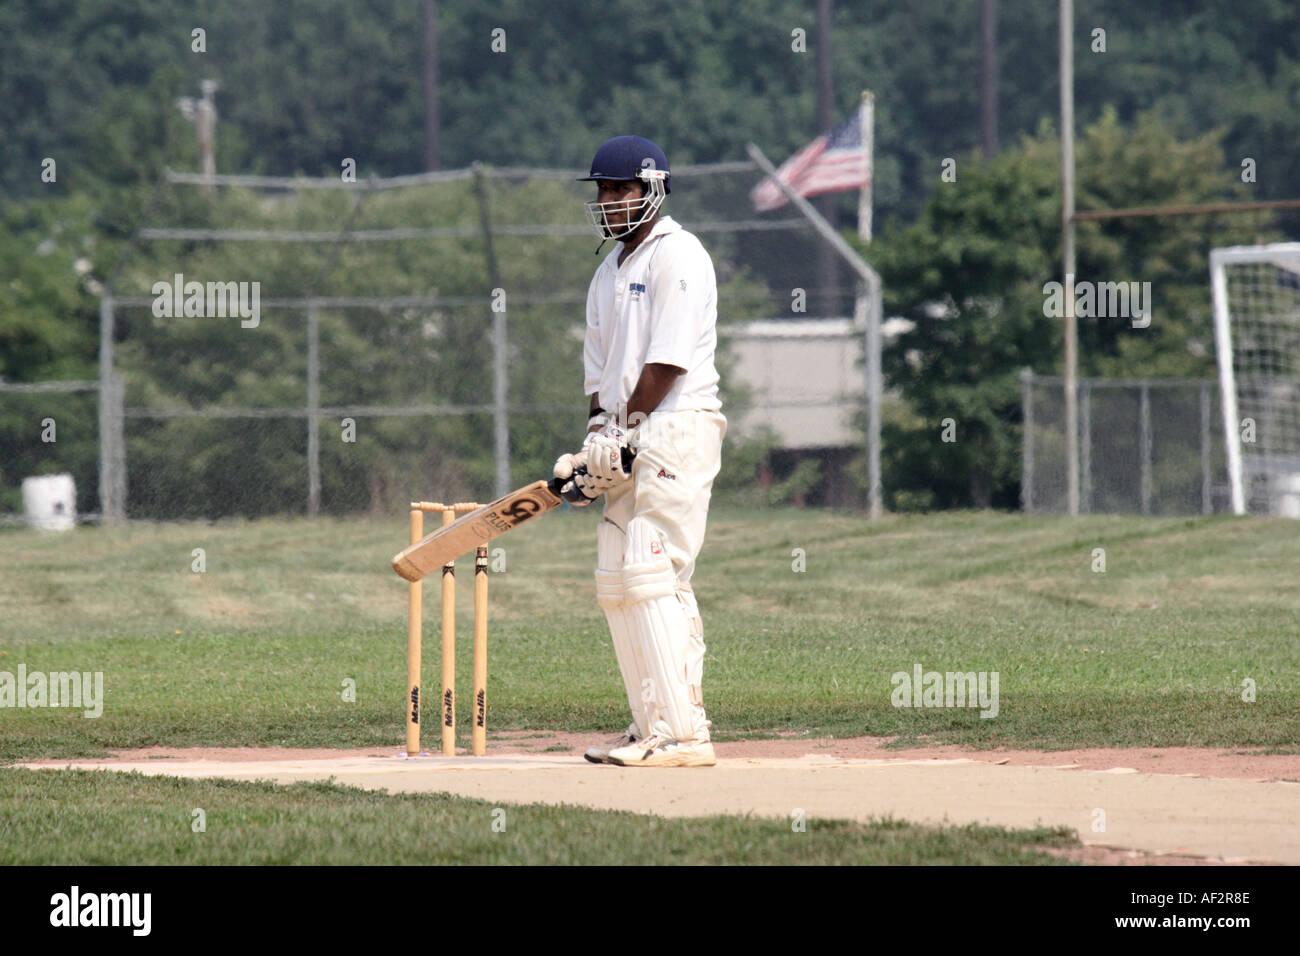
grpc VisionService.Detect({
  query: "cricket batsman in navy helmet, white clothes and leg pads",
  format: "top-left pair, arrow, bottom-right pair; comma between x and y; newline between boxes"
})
555,137 -> 727,767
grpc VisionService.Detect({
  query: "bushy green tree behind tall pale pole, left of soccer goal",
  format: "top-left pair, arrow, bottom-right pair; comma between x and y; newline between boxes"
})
863,112 -> 1274,507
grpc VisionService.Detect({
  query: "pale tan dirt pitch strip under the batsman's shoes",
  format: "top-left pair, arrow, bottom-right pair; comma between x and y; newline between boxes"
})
22,732 -> 1300,864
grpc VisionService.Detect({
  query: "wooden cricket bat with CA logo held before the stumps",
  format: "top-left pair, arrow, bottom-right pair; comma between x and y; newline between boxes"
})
393,449 -> 634,581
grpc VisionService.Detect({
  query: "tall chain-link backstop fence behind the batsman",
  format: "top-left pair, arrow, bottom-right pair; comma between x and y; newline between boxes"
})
0,161 -> 863,520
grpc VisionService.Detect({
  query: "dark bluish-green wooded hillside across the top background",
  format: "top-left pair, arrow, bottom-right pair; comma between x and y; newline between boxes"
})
0,0 -> 1300,221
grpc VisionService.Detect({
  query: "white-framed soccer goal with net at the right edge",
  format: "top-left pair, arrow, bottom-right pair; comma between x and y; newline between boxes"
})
1210,242 -> 1300,518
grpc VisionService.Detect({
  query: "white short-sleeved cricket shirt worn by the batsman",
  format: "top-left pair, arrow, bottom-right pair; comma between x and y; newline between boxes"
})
584,216 -> 722,411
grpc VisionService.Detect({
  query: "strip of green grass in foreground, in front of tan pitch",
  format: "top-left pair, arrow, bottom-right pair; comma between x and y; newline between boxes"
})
0,770 -> 1078,865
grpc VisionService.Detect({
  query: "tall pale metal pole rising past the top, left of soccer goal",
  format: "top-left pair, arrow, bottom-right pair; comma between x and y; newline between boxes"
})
1061,0 -> 1079,515
